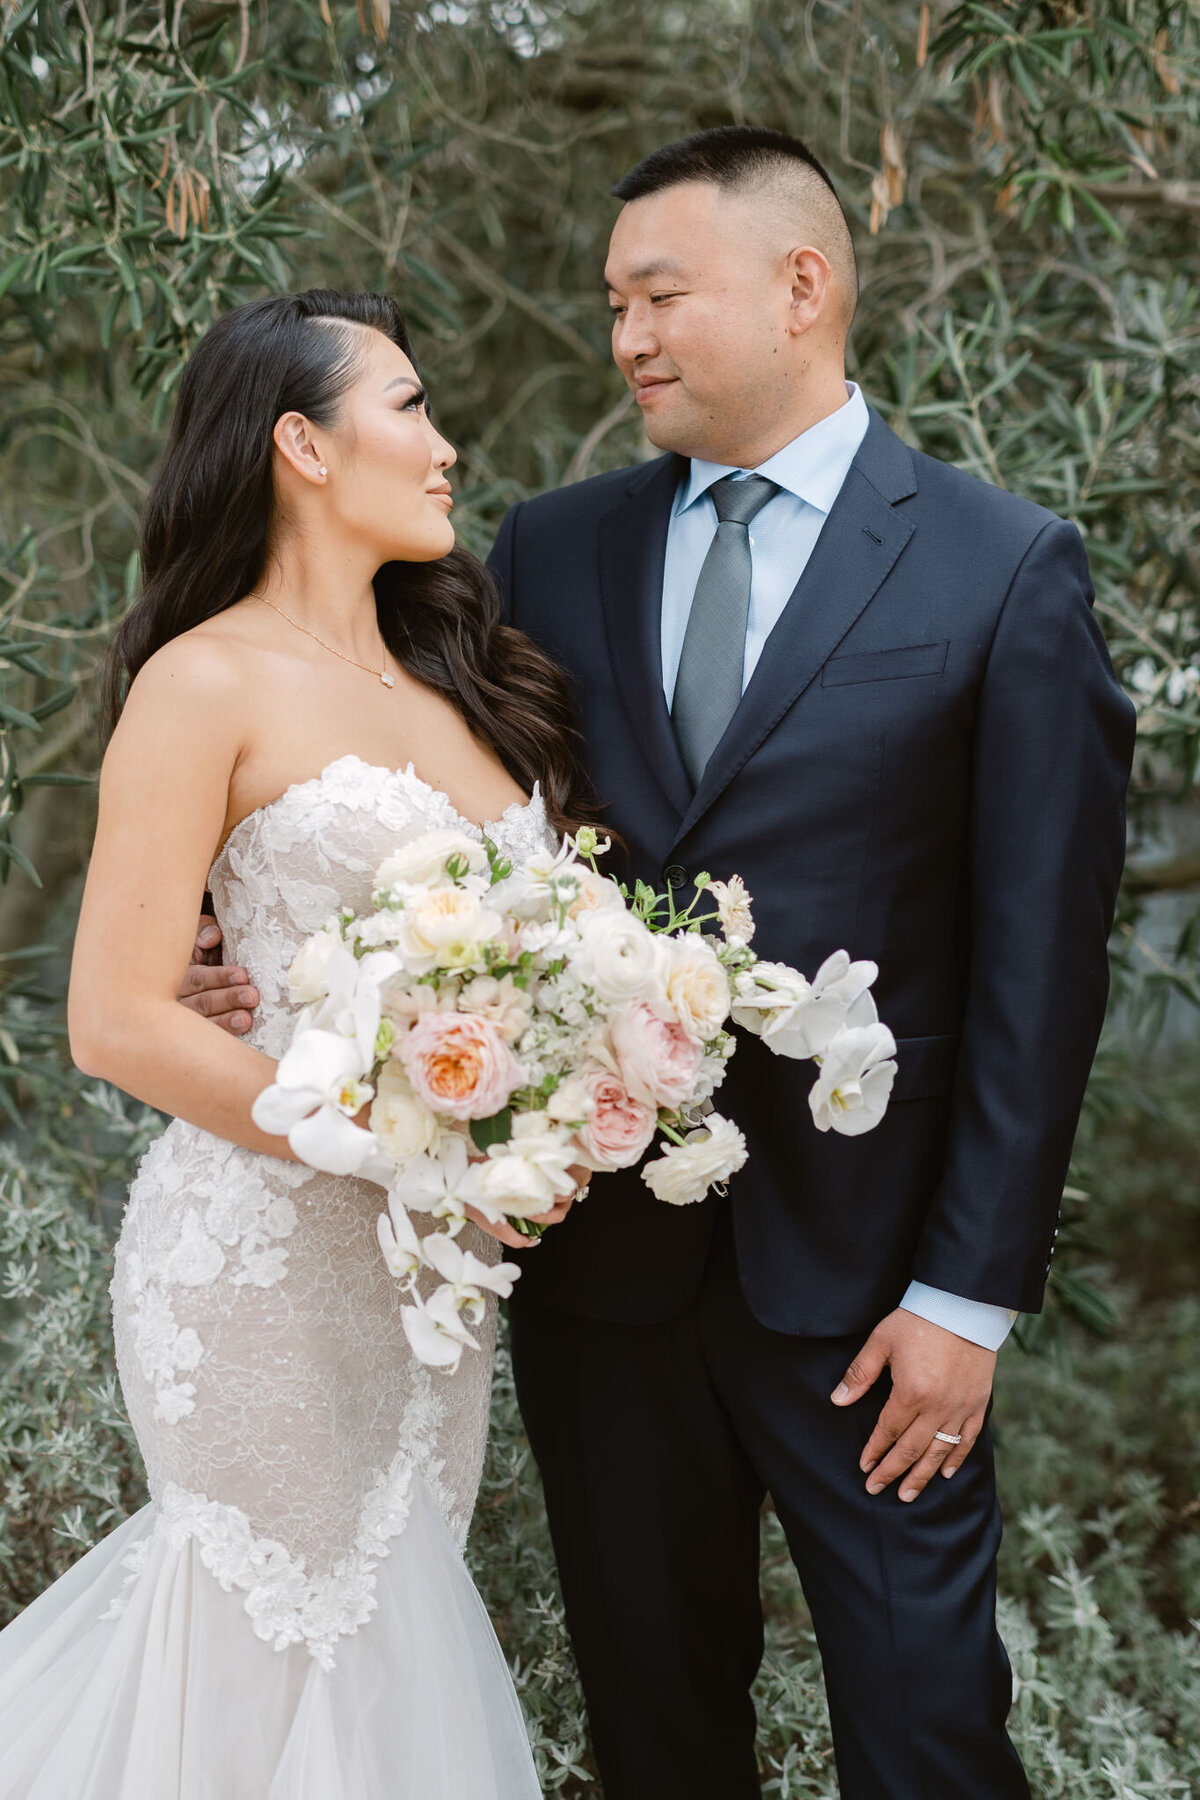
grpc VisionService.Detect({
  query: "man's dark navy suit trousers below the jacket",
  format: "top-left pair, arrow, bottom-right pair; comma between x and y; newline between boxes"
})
511,1202 -> 1029,1800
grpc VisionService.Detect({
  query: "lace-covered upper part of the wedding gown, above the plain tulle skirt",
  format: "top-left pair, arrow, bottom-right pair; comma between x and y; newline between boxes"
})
113,756 -> 549,1663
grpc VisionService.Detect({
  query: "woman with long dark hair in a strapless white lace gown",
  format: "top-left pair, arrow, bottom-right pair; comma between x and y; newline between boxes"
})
0,290 -> 581,1800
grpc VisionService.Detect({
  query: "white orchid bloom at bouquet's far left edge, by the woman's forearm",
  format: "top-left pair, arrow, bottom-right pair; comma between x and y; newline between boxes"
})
250,1028 -> 378,1175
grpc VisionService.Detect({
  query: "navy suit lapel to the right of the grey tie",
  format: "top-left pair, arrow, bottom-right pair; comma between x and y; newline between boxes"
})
664,412 -> 916,842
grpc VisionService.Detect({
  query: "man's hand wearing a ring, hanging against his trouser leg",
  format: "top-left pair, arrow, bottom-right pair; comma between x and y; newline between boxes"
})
833,1307 -> 997,1501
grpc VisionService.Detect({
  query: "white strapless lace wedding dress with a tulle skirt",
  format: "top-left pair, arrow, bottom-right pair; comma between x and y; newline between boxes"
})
0,756 -> 547,1800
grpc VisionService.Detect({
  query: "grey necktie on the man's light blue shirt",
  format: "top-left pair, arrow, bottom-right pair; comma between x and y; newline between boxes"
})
671,475 -> 779,787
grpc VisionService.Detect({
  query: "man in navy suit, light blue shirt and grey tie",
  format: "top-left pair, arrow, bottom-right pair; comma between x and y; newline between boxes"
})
185,128 -> 1133,1800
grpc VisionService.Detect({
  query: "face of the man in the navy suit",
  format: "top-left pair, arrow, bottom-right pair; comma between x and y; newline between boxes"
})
604,182 -> 792,466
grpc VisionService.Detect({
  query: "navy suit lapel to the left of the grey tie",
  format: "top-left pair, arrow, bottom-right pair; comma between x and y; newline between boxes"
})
599,455 -> 691,815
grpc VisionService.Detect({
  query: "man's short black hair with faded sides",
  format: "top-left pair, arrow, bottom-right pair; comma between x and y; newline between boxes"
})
612,124 -> 858,326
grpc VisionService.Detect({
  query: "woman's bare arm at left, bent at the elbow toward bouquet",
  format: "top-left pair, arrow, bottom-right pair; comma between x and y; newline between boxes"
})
68,637 -> 295,1161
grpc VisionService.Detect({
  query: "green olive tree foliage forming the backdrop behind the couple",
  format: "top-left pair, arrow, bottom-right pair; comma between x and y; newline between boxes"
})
0,0 -> 1200,1796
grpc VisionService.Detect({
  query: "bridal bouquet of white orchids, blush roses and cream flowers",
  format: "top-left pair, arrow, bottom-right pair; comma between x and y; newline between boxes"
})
254,830 -> 896,1368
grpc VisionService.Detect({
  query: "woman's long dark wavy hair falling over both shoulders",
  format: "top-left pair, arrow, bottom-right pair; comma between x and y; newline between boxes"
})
103,288 -> 590,828
